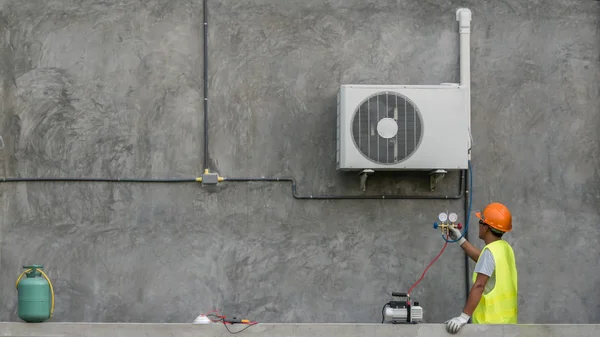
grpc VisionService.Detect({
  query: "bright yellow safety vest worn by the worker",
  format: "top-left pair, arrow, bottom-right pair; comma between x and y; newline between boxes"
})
471,240 -> 519,324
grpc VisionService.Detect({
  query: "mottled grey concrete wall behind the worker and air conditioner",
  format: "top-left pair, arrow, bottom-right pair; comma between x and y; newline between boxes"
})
0,0 -> 600,323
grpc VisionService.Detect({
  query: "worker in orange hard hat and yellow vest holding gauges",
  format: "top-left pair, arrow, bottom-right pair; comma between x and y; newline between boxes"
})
445,203 -> 518,334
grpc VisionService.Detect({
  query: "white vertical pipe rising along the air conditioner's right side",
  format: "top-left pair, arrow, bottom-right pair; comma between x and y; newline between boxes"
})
456,8 -> 473,160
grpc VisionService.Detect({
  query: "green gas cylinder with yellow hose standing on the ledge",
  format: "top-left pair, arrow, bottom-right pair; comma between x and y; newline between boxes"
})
16,265 -> 54,323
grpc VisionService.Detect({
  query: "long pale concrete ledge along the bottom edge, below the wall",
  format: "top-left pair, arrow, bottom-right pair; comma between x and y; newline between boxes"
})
0,322 -> 600,337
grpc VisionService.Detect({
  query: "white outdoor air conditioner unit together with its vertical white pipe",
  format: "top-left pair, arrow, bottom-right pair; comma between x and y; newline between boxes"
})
337,8 -> 471,171
